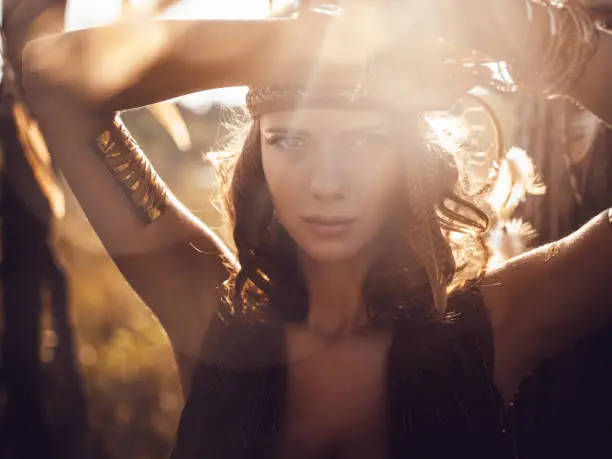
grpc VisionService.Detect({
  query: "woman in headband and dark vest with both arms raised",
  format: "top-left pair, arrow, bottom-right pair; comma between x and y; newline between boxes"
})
24,0 -> 612,458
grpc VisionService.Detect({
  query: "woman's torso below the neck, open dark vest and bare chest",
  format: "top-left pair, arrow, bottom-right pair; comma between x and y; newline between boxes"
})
173,300 -> 502,459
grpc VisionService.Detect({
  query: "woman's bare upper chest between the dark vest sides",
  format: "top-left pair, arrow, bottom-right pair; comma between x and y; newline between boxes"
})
283,330 -> 392,457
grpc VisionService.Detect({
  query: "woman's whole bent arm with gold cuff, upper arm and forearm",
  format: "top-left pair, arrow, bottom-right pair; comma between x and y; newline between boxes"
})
23,21 -> 316,388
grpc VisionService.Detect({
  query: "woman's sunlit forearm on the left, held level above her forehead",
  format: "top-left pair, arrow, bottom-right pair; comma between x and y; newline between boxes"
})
23,20 -> 364,111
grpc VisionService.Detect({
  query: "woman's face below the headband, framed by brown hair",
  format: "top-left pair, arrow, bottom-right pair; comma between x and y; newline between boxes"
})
260,109 -> 403,263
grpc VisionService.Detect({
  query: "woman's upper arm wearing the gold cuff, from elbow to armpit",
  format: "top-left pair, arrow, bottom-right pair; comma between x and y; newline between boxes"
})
26,50 -> 231,389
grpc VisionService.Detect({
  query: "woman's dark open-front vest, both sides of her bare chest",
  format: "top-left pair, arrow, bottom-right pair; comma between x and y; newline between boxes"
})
172,290 -> 512,459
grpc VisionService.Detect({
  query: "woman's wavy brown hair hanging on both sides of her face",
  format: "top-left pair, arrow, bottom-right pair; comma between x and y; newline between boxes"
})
213,113 -> 488,322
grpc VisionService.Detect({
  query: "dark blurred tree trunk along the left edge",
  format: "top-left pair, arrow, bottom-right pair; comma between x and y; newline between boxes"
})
0,0 -> 87,459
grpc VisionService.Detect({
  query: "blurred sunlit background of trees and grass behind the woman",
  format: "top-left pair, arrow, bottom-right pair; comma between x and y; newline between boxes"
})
0,0 -> 612,459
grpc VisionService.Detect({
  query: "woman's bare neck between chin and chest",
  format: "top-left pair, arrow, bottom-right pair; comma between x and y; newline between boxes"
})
300,256 -> 370,336
